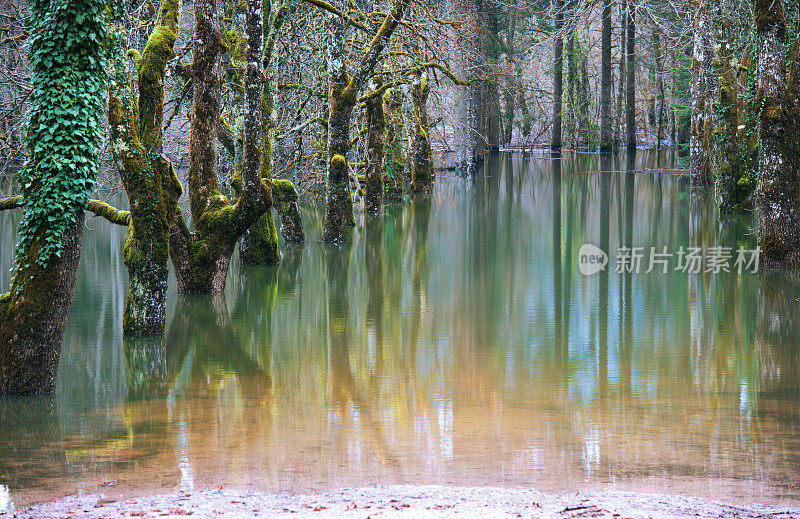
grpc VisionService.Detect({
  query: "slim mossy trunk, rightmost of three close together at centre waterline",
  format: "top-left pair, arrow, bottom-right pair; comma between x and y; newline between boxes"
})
411,73 -> 433,193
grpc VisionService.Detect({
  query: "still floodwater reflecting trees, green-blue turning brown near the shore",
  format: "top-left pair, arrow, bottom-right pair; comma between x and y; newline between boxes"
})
0,152 -> 800,510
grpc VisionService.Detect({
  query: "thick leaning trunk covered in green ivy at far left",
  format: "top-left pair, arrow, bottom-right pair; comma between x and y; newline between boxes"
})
0,0 -> 106,394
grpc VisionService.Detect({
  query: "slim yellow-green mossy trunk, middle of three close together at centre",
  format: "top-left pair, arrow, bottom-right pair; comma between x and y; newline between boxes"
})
383,88 -> 406,202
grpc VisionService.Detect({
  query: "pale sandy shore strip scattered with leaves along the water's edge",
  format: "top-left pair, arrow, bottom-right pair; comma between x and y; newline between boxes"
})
0,486 -> 800,519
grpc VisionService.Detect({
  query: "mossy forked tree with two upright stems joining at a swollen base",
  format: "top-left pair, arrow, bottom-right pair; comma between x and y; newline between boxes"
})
170,0 -> 272,293
